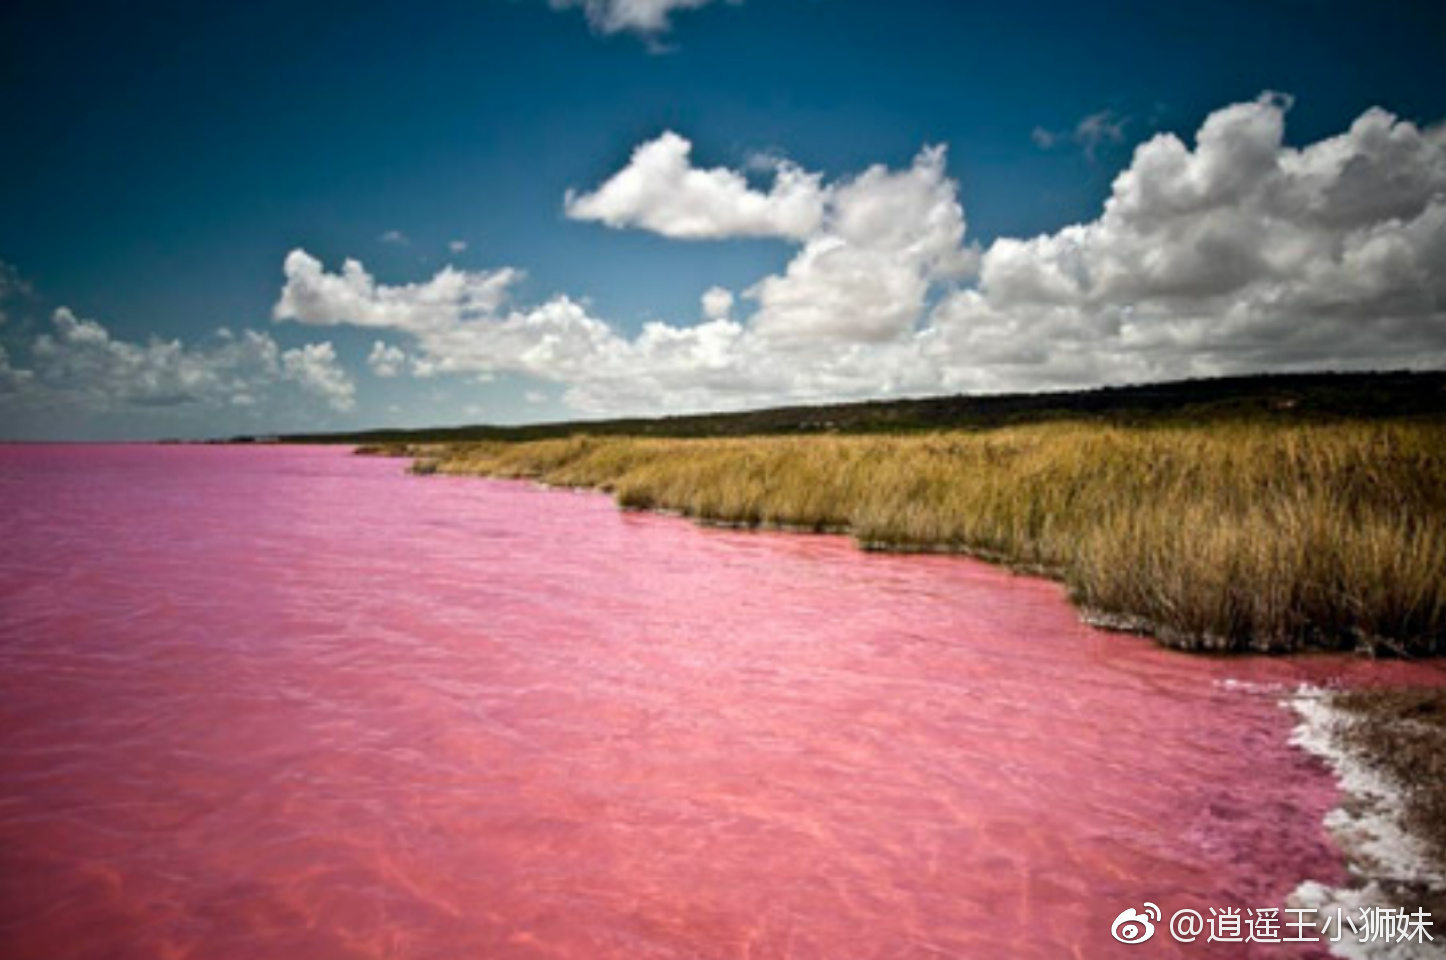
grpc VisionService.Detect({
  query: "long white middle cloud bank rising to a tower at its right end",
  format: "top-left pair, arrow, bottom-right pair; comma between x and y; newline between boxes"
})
275,136 -> 976,412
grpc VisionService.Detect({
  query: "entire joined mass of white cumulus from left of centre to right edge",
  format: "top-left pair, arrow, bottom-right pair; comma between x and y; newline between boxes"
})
276,94 -> 1446,413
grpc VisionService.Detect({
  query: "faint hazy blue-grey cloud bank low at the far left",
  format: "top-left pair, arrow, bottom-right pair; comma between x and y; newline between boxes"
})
0,307 -> 356,411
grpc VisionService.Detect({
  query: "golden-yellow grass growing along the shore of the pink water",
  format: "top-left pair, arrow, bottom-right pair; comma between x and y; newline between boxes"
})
396,422 -> 1446,655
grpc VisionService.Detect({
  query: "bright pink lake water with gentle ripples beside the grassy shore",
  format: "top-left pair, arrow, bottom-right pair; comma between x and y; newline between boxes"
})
0,447 -> 1440,960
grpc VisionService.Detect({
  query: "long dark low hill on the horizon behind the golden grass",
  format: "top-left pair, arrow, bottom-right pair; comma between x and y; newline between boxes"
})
260,370 -> 1446,444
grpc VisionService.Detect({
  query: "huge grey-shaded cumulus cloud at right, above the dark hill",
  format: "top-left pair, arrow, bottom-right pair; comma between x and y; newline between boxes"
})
937,94 -> 1446,382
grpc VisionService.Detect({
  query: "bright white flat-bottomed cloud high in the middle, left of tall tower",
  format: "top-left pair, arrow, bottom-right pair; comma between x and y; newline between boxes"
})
565,130 -> 826,240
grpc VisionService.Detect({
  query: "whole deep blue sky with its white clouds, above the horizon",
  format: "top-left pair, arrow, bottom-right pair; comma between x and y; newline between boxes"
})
0,0 -> 1446,438
